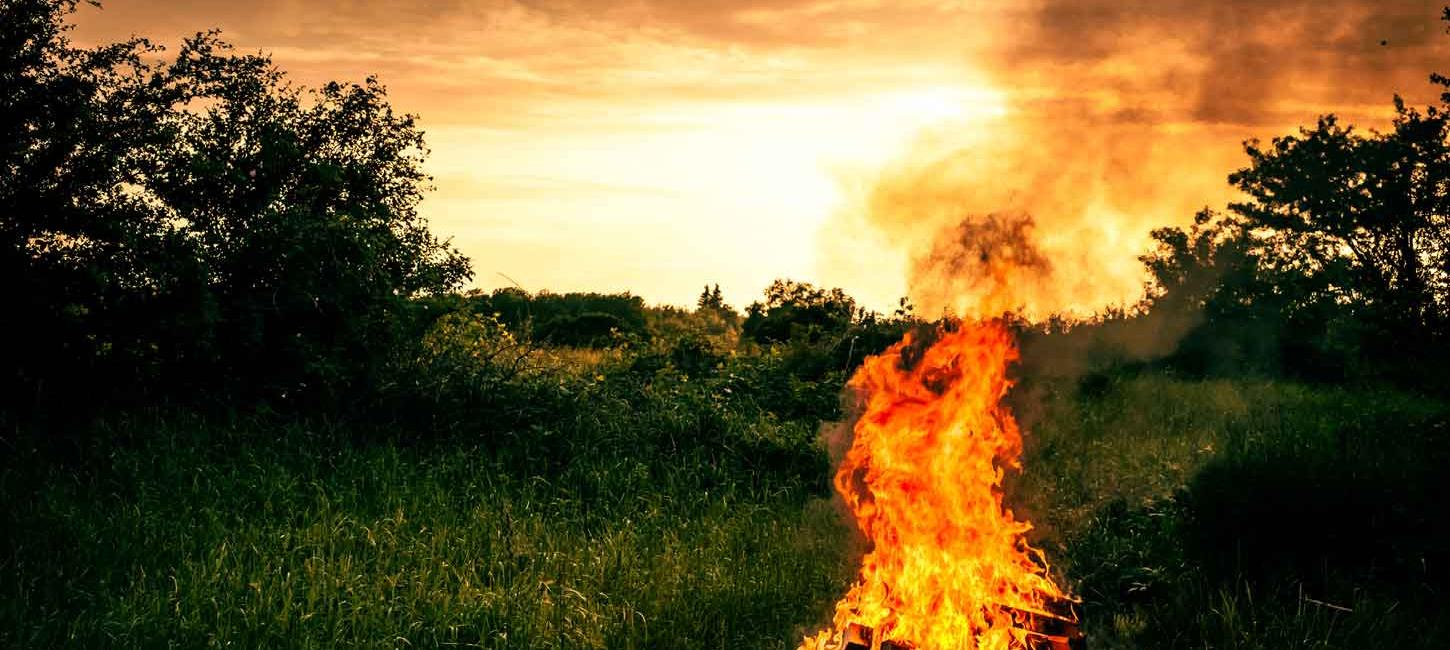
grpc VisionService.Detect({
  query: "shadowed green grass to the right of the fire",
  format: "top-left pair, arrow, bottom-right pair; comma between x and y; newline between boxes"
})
1016,376 -> 1450,649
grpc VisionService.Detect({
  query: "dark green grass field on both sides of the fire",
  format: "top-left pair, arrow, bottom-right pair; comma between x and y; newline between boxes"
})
0,376 -> 1450,649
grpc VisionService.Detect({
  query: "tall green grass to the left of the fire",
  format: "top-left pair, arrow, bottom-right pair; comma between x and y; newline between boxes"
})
0,424 -> 848,647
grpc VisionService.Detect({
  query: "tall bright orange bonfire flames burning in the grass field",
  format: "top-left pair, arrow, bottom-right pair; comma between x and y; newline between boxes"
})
802,321 -> 1067,650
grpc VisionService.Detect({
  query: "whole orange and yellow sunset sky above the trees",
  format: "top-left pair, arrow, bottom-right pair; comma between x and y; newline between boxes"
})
74,0 -> 1450,309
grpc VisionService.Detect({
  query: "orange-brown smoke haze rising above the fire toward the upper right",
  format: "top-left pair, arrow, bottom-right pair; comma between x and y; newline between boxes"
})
825,0 -> 1446,316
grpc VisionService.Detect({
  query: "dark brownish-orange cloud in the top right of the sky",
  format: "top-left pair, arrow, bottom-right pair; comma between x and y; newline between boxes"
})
999,0 -> 1446,125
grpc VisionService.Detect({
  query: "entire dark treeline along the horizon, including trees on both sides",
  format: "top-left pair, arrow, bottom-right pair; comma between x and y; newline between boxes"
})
8,0 -> 1450,432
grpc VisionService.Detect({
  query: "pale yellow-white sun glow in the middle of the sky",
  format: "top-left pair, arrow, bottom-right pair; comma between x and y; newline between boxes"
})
425,84 -> 1006,303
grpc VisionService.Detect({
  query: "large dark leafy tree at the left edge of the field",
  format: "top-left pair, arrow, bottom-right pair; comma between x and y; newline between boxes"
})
0,0 -> 470,412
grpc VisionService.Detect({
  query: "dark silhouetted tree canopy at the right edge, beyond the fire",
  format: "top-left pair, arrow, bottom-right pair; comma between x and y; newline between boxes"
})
1143,87 -> 1450,379
